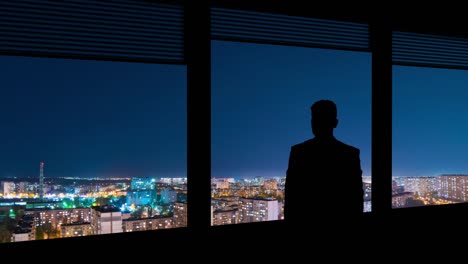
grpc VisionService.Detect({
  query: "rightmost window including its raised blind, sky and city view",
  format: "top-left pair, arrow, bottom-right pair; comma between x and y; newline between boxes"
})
392,31 -> 468,208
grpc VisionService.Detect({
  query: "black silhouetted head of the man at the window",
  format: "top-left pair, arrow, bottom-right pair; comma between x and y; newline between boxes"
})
310,100 -> 338,137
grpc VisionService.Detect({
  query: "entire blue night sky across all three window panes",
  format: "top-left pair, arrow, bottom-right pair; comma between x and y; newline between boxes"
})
0,41 -> 468,178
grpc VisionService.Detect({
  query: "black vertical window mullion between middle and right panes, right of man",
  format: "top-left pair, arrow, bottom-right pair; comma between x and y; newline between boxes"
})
370,19 -> 392,217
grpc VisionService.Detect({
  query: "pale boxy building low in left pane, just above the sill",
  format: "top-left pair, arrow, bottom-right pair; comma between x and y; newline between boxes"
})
91,205 -> 123,235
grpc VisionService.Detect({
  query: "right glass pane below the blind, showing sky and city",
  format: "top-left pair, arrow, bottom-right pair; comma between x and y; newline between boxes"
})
392,66 -> 468,208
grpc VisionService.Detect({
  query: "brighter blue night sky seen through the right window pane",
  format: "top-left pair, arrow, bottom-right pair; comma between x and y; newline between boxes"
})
393,66 -> 468,176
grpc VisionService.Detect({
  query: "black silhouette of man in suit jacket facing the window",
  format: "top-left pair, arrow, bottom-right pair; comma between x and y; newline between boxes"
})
284,100 -> 363,228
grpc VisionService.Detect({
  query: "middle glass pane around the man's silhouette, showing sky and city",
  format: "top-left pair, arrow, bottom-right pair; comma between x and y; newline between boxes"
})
211,41 -> 371,225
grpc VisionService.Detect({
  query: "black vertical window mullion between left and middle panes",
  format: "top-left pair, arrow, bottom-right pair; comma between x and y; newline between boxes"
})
184,1 -> 211,231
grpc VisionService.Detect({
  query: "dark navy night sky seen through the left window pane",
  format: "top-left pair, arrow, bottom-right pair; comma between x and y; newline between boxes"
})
0,57 -> 187,177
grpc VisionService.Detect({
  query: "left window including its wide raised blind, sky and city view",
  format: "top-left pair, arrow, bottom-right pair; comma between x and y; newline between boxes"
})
0,0 -> 187,242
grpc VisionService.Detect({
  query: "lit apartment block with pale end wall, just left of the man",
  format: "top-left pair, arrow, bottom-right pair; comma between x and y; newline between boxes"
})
239,198 -> 280,223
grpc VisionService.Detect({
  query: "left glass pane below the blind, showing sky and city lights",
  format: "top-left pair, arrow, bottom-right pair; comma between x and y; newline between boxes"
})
0,57 -> 187,242
